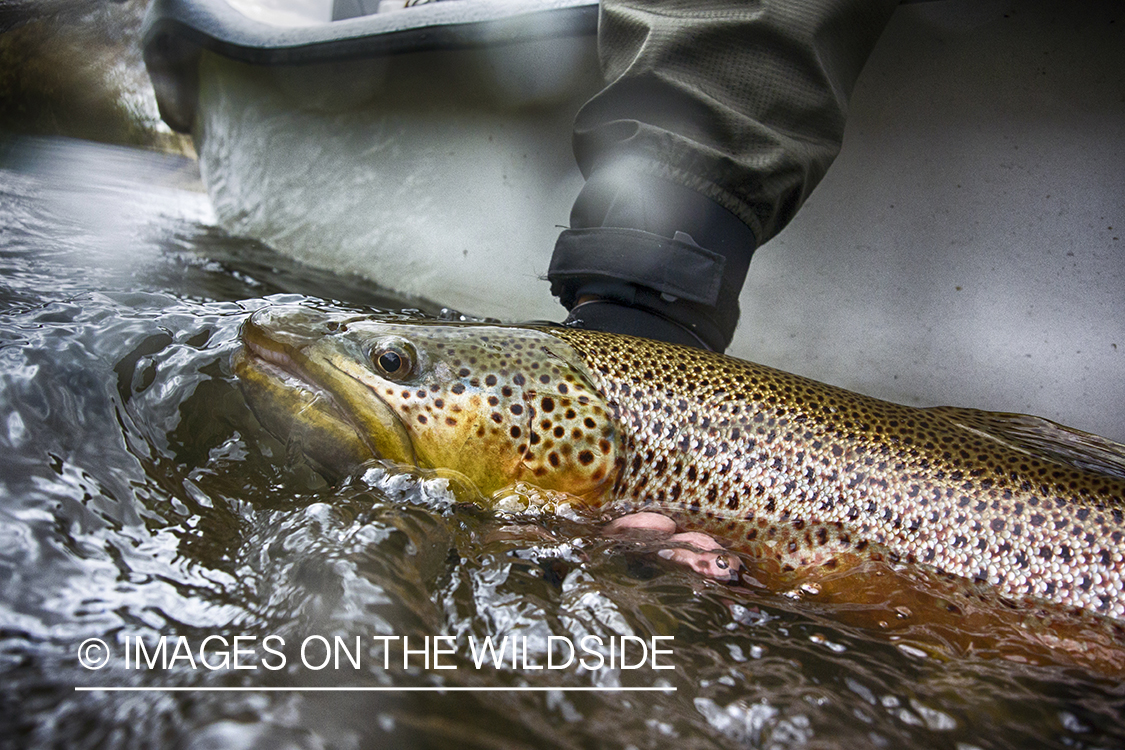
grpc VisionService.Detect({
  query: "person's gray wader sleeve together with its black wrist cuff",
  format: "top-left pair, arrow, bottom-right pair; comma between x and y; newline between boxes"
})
548,0 -> 898,350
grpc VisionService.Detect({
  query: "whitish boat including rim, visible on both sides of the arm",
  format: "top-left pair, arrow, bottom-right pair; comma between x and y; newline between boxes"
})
146,0 -> 1125,442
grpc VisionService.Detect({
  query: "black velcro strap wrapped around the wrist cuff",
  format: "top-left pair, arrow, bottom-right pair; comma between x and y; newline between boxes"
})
547,227 -> 727,307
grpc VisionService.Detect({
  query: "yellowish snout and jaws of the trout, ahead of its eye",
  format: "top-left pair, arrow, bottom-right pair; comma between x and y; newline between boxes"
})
232,307 -> 414,473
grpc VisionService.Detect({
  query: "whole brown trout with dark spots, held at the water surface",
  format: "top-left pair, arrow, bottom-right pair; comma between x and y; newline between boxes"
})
234,307 -> 1125,620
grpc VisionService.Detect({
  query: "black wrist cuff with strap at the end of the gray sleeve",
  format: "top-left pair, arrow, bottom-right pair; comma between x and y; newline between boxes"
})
547,169 -> 756,352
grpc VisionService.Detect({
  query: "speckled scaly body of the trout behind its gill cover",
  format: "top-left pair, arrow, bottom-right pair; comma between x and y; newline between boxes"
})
550,328 -> 1125,618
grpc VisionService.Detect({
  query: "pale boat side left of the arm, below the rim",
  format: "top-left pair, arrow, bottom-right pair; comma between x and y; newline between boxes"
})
194,37 -> 601,318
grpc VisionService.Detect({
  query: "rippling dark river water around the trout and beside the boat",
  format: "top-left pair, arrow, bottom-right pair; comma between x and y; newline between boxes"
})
0,141 -> 1125,750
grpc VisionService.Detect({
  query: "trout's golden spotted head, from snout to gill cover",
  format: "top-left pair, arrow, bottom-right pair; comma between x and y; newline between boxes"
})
234,306 -> 623,503
